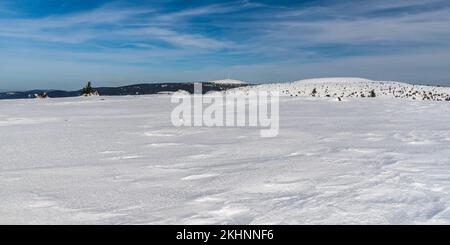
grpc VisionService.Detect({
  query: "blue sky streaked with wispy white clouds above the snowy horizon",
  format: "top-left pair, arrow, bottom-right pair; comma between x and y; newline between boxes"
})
0,0 -> 450,90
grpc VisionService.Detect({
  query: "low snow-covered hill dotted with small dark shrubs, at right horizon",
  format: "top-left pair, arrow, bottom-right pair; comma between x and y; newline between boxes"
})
230,77 -> 450,101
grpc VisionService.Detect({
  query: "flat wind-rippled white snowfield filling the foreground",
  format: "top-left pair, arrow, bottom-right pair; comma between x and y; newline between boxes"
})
0,91 -> 450,224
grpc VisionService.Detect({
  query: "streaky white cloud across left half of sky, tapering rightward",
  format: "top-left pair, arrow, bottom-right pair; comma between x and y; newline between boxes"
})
0,2 -> 234,49
